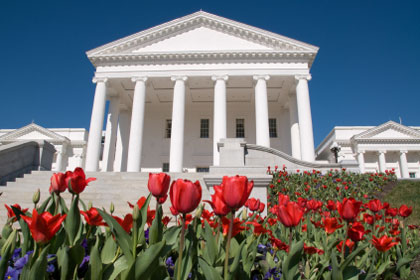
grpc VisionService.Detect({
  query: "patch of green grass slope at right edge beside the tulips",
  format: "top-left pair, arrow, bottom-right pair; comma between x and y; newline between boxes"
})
383,180 -> 420,225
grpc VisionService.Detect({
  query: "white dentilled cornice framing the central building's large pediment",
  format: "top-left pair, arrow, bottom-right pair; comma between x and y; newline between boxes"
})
87,11 -> 318,66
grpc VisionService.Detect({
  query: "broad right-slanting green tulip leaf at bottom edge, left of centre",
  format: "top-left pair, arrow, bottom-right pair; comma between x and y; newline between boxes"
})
135,240 -> 165,279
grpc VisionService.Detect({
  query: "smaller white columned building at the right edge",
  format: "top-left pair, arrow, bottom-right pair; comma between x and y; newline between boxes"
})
316,121 -> 420,178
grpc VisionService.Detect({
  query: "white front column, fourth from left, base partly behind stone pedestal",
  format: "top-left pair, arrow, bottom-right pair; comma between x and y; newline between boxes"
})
212,75 -> 228,166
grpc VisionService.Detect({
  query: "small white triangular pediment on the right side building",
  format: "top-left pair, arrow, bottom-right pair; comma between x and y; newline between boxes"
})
354,121 -> 420,140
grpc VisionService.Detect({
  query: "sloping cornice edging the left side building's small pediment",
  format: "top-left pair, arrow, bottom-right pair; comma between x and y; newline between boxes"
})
0,123 -> 70,143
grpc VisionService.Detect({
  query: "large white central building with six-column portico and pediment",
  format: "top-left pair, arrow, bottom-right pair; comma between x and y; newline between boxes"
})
85,11 -> 318,172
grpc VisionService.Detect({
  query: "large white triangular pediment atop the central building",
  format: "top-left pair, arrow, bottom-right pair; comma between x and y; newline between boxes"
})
87,11 -> 318,62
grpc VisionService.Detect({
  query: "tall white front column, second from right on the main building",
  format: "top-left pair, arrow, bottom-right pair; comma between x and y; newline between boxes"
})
254,75 -> 270,147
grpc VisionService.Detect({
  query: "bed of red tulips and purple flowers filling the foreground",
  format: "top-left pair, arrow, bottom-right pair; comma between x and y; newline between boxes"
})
0,167 -> 420,280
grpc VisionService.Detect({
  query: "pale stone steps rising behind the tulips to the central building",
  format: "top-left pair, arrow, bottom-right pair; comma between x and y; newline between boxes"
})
0,171 -> 210,227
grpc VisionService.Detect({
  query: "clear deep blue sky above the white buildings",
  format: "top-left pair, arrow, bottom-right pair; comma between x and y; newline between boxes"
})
0,0 -> 420,145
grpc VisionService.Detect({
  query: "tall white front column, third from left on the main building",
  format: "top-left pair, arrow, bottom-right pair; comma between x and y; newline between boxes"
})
169,76 -> 188,172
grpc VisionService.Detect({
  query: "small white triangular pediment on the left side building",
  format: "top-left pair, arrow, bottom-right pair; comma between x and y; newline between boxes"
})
0,123 -> 69,142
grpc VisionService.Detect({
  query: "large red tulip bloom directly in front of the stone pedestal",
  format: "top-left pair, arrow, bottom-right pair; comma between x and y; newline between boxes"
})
222,175 -> 254,210
